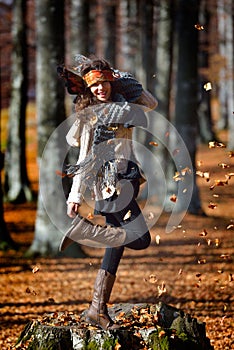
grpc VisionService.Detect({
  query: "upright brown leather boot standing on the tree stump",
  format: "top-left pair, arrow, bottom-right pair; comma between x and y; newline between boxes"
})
86,269 -> 120,330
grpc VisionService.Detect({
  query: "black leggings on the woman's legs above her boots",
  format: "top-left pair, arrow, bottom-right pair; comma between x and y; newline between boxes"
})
101,181 -> 151,275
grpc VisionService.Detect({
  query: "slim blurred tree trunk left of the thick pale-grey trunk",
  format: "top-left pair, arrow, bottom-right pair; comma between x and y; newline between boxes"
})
4,0 -> 32,203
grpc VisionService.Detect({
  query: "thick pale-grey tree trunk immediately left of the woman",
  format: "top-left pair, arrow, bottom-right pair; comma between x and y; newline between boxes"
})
27,0 -> 84,257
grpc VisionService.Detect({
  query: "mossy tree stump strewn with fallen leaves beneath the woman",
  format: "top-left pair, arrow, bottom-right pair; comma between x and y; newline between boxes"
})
16,302 -> 213,350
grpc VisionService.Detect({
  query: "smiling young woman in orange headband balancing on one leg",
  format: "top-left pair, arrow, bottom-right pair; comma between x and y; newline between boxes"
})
60,58 -> 157,330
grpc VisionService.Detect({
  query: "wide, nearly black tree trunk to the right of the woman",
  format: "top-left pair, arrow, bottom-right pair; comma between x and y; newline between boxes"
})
175,0 -> 202,214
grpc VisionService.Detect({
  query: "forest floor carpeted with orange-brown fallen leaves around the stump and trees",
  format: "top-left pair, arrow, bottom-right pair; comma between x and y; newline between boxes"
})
0,121 -> 234,350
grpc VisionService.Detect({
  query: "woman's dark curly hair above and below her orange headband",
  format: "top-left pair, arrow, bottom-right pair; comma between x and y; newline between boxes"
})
75,56 -> 112,112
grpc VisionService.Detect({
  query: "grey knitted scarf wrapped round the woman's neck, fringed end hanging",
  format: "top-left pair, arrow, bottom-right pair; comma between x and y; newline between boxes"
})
65,102 -> 147,187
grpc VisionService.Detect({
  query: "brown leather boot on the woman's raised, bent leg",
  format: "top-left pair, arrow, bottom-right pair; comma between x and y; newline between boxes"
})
59,214 -> 126,251
